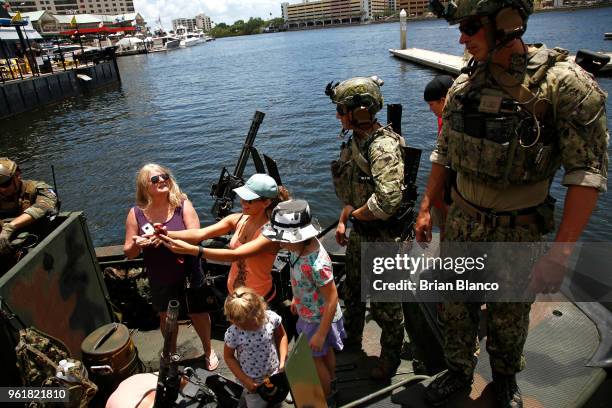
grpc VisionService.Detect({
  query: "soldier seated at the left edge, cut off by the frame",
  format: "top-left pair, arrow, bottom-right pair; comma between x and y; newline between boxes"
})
0,157 -> 57,257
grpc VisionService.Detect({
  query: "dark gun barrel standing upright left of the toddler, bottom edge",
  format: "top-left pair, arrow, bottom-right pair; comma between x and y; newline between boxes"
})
153,300 -> 180,408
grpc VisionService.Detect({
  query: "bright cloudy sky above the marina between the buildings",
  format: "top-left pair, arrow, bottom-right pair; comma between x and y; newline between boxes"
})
134,0 -> 284,29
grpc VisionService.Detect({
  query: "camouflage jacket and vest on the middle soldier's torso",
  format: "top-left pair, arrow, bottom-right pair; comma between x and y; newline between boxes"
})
332,128 -> 404,220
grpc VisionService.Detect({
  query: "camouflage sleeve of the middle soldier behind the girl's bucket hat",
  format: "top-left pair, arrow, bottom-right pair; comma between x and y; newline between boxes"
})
367,136 -> 404,220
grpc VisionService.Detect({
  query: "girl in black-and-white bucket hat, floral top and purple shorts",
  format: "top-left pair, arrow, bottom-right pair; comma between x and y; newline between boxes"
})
262,200 -> 346,400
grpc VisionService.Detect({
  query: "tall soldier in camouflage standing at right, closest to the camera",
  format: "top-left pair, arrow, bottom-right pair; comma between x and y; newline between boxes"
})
415,0 -> 608,407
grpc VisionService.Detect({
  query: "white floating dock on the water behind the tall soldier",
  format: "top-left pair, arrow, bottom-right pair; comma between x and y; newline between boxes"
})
389,48 -> 612,76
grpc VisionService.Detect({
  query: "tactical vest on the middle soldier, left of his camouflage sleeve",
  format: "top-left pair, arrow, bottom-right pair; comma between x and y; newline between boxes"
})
331,126 -> 405,208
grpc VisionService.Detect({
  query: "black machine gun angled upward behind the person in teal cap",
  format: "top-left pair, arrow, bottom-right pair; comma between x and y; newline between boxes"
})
210,111 -> 265,220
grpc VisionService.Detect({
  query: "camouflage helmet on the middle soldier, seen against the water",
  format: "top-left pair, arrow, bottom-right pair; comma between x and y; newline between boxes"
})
325,76 -> 384,114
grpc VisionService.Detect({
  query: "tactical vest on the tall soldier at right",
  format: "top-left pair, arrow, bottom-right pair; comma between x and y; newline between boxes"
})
445,50 -> 565,187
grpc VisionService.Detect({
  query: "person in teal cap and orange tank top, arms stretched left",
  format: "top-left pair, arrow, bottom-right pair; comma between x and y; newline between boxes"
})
160,173 -> 289,301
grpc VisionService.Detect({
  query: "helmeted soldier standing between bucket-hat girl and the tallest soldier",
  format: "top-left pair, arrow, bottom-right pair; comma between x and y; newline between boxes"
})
326,77 -> 404,380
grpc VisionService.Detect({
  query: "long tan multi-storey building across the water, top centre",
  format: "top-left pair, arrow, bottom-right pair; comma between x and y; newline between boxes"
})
281,0 -> 388,28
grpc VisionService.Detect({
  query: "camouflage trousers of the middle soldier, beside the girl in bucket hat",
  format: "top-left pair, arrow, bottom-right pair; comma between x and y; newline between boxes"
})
344,230 -> 404,363
